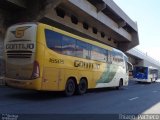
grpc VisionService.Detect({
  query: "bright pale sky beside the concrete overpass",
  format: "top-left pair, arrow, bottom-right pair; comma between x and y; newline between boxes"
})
113,0 -> 160,61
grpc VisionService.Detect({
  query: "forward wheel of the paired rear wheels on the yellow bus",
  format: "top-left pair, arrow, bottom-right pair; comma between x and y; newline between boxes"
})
77,78 -> 88,95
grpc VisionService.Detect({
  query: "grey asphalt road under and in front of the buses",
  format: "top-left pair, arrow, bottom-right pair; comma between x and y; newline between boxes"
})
0,81 -> 160,119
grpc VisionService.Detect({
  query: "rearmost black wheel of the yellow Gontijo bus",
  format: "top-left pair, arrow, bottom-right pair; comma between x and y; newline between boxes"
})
65,78 -> 76,97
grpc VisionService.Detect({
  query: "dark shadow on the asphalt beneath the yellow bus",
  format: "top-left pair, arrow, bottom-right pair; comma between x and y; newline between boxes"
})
5,87 -> 125,101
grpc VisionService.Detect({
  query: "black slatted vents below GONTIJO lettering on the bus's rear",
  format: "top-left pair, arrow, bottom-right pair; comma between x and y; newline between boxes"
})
7,51 -> 32,58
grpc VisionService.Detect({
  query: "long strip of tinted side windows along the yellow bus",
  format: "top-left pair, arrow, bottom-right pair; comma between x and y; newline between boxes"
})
45,29 -> 111,62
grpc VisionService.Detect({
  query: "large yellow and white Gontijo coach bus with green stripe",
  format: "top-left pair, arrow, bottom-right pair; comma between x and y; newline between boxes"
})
5,23 -> 132,96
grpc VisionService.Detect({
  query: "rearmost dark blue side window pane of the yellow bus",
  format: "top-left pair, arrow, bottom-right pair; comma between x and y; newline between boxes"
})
45,29 -> 62,53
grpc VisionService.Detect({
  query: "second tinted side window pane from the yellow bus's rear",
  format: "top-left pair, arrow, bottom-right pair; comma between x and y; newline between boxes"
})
62,35 -> 76,56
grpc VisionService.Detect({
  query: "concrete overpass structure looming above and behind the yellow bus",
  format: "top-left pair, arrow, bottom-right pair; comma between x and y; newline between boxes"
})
0,0 -> 159,79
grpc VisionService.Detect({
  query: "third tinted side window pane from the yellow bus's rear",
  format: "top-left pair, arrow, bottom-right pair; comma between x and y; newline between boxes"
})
76,41 -> 91,59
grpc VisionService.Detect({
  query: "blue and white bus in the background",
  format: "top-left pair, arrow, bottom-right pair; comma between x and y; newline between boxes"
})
133,66 -> 158,83
